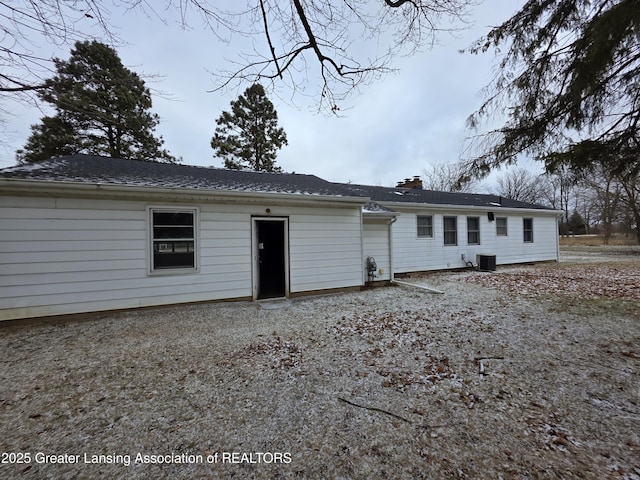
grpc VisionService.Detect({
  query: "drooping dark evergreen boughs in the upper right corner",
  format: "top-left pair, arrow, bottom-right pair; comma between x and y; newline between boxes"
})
469,0 -> 640,176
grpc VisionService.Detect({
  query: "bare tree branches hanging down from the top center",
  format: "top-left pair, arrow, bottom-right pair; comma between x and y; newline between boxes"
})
210,0 -> 473,111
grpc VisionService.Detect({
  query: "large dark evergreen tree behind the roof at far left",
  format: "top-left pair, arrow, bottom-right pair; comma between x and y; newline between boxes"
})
17,40 -> 177,163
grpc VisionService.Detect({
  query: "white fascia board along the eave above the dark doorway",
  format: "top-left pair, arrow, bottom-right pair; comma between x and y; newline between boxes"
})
0,178 -> 370,207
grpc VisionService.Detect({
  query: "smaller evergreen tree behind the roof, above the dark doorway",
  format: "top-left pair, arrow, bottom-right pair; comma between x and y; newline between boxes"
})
211,83 -> 287,172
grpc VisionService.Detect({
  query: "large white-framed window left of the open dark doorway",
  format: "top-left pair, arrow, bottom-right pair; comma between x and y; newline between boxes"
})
150,209 -> 196,272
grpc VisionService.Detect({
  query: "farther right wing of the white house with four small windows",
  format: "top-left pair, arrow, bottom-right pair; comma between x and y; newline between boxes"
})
345,177 -> 559,274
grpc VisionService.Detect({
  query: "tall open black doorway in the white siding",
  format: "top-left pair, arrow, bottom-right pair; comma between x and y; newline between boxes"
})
256,220 -> 286,298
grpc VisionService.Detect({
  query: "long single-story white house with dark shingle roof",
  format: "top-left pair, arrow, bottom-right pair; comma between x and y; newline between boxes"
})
0,155 -> 557,320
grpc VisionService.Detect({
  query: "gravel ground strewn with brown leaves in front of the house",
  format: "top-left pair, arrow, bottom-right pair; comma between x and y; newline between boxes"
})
0,249 -> 640,479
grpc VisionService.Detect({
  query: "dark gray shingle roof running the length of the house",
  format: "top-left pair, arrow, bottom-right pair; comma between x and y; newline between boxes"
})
0,154 -> 547,211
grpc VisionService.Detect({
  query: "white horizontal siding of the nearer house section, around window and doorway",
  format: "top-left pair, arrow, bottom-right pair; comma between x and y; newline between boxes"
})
0,196 -> 363,320
